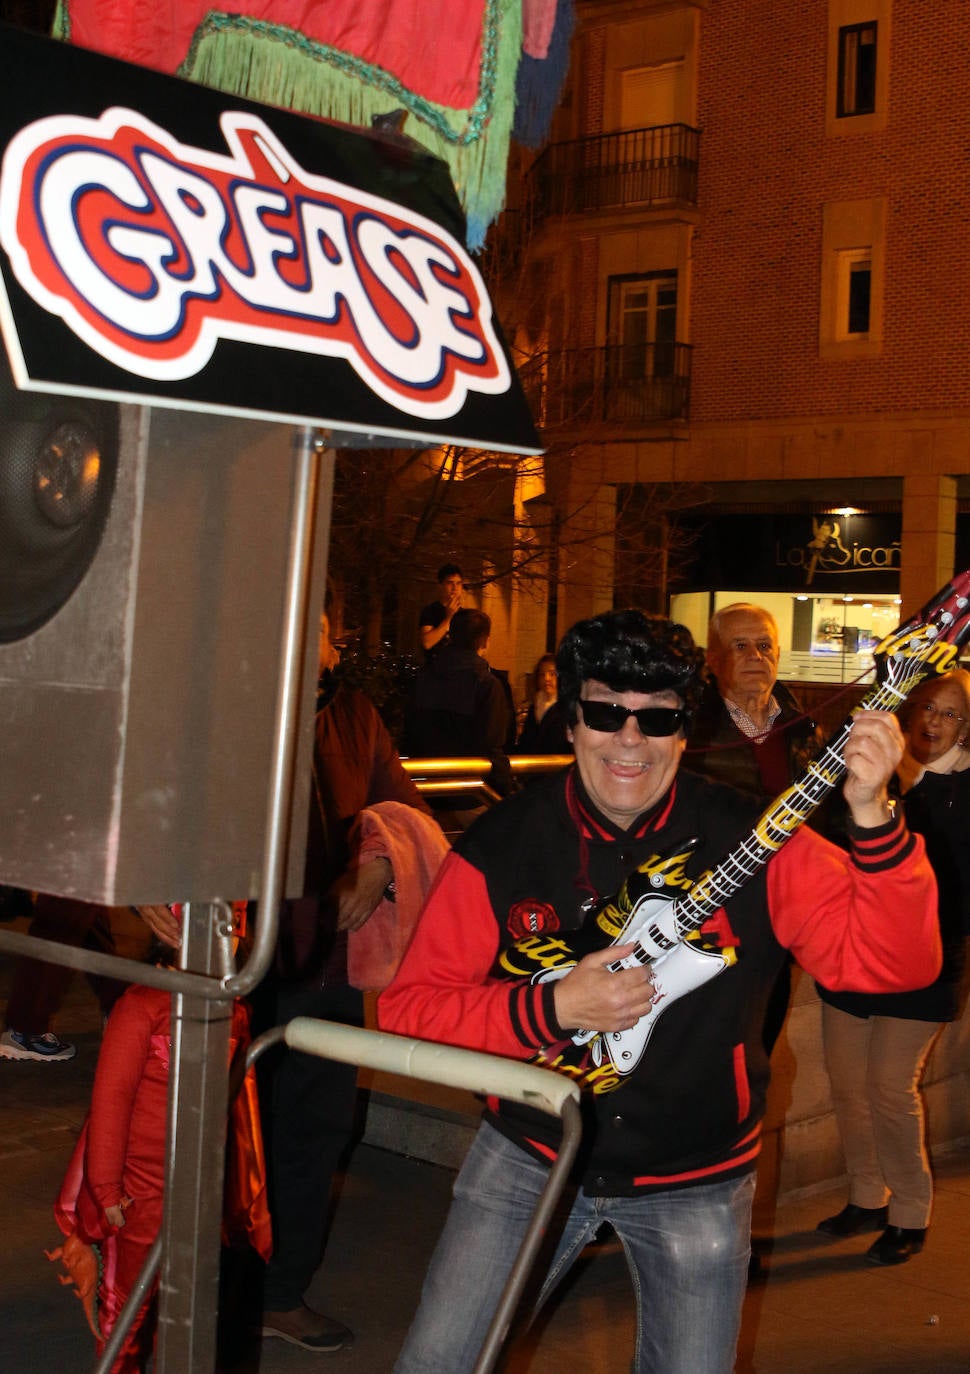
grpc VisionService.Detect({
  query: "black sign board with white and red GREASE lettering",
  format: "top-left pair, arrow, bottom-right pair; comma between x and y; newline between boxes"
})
0,25 -> 540,453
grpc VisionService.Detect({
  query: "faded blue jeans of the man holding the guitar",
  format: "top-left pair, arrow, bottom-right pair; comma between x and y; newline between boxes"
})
394,1124 -> 754,1374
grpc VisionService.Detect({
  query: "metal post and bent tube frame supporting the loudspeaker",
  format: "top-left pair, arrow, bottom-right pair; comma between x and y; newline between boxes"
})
87,426 -> 324,1374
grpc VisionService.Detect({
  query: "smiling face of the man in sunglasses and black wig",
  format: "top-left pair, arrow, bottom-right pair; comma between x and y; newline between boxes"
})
569,679 -> 686,830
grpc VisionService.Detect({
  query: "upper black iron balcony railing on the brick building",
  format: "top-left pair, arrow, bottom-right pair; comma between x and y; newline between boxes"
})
526,124 -> 701,218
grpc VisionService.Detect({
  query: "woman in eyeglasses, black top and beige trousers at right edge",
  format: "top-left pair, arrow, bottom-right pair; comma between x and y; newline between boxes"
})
817,668 -> 970,1264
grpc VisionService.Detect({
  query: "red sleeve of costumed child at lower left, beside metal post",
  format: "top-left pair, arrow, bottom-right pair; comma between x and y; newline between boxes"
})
84,996 -> 154,1230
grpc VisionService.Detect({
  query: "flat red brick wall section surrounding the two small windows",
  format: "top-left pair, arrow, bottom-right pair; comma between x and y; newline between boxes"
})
691,0 -> 970,417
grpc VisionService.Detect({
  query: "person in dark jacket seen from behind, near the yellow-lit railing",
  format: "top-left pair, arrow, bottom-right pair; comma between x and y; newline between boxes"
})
404,607 -> 512,797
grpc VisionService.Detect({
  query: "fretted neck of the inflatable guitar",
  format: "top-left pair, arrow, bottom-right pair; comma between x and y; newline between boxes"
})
664,683 -> 905,938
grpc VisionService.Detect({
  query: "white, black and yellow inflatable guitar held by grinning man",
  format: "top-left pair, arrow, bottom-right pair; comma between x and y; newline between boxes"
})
501,569 -> 970,1092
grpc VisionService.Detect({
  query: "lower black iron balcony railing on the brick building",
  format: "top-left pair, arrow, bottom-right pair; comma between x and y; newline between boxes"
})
519,344 -> 691,429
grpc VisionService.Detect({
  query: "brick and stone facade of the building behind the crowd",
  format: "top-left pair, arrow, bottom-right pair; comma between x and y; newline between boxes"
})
535,0 -> 970,627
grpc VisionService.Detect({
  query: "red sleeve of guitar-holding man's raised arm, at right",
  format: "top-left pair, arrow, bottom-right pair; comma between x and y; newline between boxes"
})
768,816 -> 941,992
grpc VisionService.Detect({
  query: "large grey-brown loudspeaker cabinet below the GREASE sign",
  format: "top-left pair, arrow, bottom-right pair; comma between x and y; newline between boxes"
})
0,349 -> 330,904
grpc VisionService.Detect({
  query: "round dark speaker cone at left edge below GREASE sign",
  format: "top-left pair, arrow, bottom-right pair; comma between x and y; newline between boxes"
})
0,362 -> 118,643
